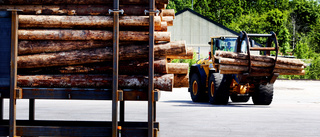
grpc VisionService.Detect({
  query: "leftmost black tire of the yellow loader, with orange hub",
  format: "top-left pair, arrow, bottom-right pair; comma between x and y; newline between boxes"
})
189,74 -> 208,102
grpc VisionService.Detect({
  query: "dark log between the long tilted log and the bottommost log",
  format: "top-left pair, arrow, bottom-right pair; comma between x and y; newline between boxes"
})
18,59 -> 168,75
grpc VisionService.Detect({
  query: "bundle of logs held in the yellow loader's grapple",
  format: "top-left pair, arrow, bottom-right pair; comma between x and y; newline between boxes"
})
215,51 -> 306,76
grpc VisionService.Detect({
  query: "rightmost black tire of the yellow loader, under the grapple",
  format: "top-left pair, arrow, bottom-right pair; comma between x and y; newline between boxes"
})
252,84 -> 273,105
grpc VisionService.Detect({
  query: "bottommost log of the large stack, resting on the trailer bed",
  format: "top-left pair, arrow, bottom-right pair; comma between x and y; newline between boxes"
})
17,74 -> 174,91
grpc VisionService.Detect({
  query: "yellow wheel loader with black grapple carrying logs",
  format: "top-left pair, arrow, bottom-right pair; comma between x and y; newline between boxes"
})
189,31 -> 279,105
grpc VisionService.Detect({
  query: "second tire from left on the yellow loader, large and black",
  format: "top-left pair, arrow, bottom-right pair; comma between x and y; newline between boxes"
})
208,73 -> 231,105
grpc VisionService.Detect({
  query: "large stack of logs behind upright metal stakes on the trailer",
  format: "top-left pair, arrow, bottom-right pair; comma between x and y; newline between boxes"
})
0,0 -> 193,91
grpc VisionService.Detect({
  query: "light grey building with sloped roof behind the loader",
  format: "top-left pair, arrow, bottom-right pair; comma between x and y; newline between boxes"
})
168,8 -> 238,58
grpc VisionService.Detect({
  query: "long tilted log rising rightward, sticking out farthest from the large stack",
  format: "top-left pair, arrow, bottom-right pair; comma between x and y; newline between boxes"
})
17,41 -> 185,68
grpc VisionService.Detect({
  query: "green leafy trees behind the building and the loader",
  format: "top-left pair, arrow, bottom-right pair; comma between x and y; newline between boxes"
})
167,0 -> 320,79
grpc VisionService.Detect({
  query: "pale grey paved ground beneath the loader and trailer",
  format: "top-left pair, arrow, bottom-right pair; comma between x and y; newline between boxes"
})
4,80 -> 320,137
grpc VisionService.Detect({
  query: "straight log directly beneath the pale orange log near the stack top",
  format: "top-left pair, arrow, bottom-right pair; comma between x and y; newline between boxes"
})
18,29 -> 171,41
